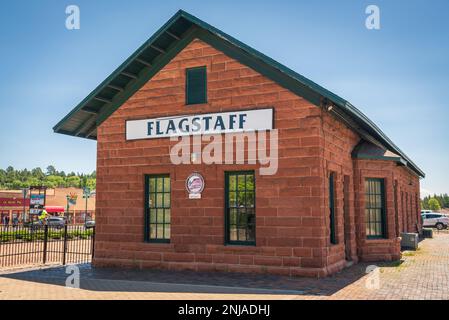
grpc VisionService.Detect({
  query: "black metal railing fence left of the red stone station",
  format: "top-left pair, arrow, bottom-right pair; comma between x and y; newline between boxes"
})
0,225 -> 95,268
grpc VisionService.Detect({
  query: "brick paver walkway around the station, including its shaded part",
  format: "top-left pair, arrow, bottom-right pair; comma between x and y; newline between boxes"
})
0,233 -> 449,300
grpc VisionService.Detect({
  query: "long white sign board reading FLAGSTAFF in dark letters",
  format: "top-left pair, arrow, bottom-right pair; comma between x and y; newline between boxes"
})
126,108 -> 273,140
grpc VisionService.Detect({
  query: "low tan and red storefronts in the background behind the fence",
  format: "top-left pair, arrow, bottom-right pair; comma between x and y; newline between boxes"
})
0,188 -> 95,224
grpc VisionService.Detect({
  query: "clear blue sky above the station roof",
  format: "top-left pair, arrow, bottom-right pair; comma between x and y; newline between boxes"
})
0,0 -> 449,193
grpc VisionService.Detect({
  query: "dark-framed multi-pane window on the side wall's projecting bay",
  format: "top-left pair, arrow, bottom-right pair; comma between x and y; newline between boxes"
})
365,178 -> 386,239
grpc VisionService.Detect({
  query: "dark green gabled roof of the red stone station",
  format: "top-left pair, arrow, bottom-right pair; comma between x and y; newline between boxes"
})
53,10 -> 425,177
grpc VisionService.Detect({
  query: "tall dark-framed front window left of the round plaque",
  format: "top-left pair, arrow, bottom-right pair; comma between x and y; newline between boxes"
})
145,174 -> 171,243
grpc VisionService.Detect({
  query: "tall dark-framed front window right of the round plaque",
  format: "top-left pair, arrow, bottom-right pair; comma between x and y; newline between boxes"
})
225,171 -> 256,245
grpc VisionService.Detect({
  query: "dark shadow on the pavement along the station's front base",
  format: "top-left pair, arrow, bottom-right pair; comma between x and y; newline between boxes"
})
0,263 -> 380,296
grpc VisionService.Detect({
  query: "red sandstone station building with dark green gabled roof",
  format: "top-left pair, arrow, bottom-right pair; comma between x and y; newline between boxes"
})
54,11 -> 424,276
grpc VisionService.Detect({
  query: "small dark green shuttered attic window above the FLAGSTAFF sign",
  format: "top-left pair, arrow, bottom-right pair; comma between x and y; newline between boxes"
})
186,67 -> 207,105
